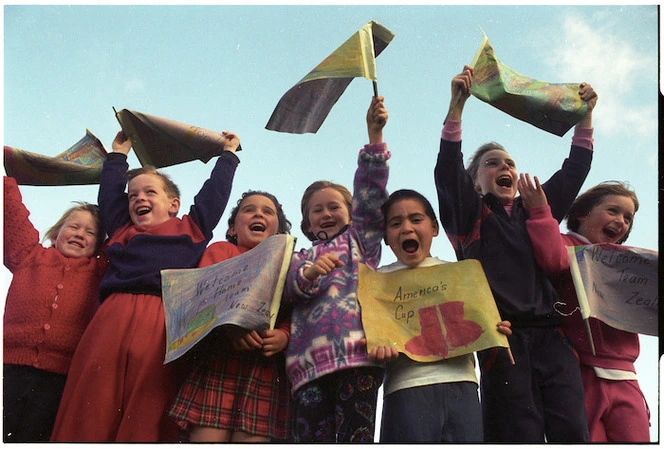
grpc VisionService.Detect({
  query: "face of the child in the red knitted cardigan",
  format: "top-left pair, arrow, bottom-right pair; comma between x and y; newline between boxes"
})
51,210 -> 97,257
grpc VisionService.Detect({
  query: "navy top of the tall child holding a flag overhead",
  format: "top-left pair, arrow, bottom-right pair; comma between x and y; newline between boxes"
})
434,139 -> 593,327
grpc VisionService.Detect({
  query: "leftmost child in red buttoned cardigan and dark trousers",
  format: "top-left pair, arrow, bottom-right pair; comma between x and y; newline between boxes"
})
3,177 -> 108,443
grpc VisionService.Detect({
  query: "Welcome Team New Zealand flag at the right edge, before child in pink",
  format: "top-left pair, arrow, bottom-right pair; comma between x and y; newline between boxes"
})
567,243 -> 659,339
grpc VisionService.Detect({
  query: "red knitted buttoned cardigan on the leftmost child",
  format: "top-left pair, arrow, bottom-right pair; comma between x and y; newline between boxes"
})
3,177 -> 108,374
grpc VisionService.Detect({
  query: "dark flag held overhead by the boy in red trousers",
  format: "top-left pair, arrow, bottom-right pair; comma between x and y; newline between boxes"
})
114,109 -> 242,168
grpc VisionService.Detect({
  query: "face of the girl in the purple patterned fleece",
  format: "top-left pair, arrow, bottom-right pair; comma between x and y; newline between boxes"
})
309,187 -> 350,239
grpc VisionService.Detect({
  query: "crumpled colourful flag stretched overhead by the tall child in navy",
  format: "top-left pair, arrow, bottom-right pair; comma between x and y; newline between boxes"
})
470,32 -> 587,136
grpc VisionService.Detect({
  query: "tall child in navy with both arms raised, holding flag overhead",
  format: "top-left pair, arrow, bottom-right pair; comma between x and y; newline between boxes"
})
434,66 -> 597,442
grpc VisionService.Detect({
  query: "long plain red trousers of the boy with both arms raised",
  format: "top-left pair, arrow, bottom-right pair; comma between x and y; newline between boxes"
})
51,293 -> 178,443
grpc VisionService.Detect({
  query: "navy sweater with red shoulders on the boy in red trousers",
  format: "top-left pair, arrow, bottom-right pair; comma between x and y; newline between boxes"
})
98,151 -> 240,301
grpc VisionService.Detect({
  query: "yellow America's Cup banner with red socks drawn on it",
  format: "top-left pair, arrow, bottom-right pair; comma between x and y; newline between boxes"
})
358,260 -> 509,362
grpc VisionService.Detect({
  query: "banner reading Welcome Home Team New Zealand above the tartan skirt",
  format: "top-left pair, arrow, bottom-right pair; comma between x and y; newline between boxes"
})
161,234 -> 295,364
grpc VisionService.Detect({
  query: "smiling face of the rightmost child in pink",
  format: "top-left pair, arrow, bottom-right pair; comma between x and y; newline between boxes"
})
578,195 -> 634,243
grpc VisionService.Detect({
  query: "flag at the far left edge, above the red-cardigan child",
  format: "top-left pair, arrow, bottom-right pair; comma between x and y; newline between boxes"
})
4,129 -> 107,186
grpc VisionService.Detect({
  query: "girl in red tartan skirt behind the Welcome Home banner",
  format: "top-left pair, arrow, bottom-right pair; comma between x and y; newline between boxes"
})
169,191 -> 291,443
